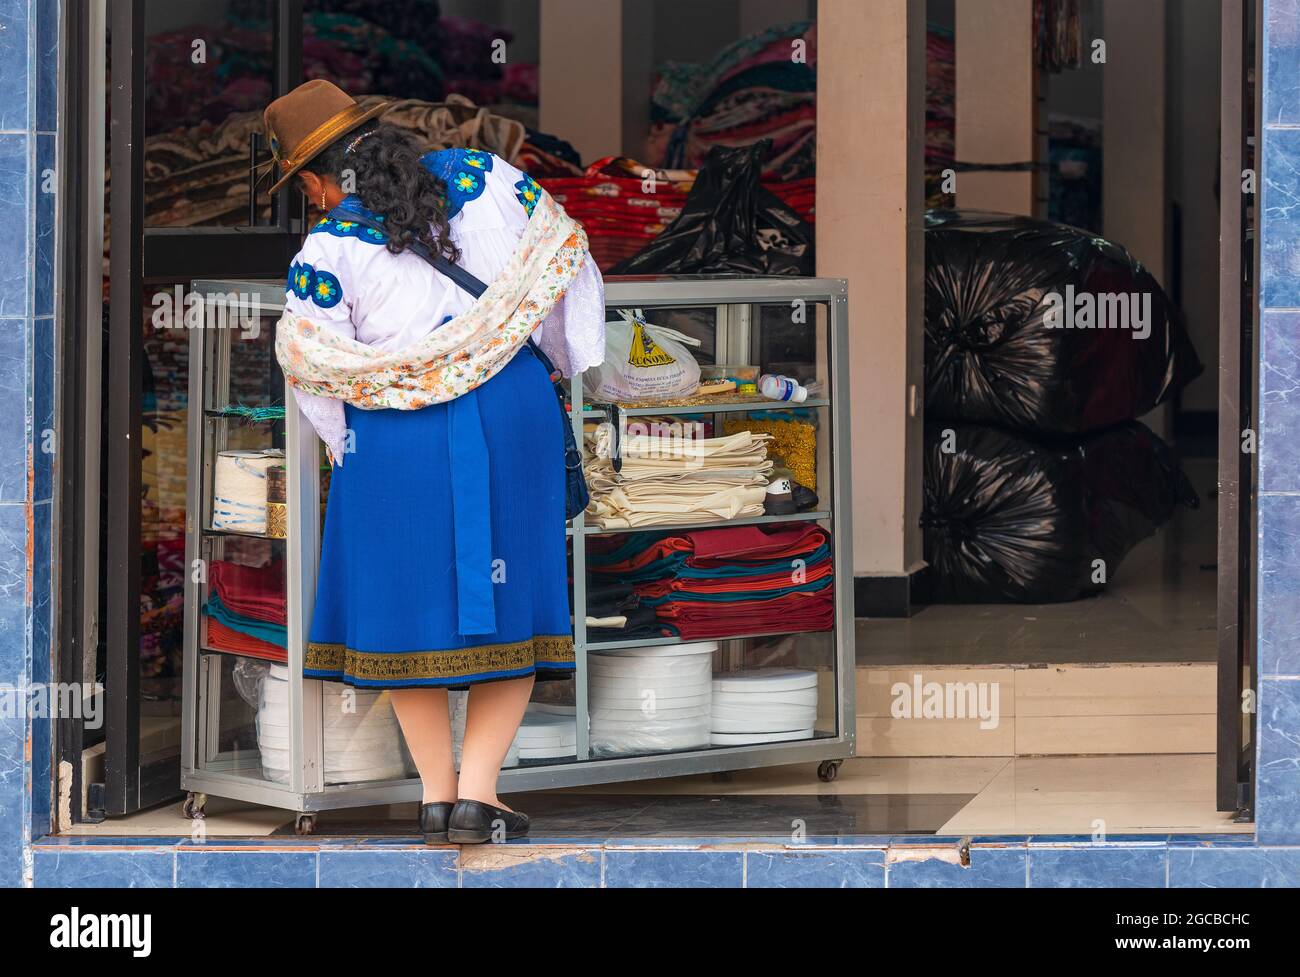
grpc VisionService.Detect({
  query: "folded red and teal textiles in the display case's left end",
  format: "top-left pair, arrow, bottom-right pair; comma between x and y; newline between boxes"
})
203,560 -> 289,663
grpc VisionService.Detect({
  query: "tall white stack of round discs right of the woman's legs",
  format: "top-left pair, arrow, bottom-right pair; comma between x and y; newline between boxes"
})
588,642 -> 718,756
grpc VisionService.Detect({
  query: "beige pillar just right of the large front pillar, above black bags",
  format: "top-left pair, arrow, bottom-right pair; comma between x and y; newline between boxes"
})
956,0 -> 1047,217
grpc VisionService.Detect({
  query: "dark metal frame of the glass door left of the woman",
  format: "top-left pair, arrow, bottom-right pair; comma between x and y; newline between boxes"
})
100,0 -> 303,816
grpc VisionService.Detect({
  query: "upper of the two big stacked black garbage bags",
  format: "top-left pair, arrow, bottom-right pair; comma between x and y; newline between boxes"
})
926,210 -> 1203,434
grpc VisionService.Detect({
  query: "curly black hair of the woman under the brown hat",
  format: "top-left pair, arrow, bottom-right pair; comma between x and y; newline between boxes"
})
303,122 -> 460,261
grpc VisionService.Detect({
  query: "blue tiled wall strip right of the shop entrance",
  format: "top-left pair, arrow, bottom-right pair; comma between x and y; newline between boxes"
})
1256,0 -> 1300,844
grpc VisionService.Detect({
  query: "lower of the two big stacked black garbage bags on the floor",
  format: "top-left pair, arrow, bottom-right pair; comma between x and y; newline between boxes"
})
918,421 -> 1197,604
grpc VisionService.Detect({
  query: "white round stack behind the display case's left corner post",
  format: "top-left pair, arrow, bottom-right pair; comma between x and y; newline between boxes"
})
257,665 -> 410,783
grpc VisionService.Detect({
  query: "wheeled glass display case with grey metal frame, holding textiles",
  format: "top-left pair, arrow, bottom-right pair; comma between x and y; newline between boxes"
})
182,277 -> 855,833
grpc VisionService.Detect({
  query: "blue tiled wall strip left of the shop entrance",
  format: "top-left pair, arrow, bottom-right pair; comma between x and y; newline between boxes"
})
0,0 -> 59,885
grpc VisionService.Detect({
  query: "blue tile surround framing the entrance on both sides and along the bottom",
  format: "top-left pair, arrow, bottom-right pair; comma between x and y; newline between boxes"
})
12,0 -> 1300,887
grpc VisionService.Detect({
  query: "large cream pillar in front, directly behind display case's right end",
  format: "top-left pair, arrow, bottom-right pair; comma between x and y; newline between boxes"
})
816,0 -> 926,583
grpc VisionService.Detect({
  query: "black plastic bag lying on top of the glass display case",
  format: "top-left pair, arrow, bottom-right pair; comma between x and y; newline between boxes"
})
610,139 -> 814,275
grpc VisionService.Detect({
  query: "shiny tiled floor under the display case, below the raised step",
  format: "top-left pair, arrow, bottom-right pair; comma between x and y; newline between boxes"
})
63,755 -> 1253,839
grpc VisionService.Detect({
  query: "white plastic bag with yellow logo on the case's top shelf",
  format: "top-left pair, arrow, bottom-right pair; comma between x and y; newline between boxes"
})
592,309 -> 699,404
